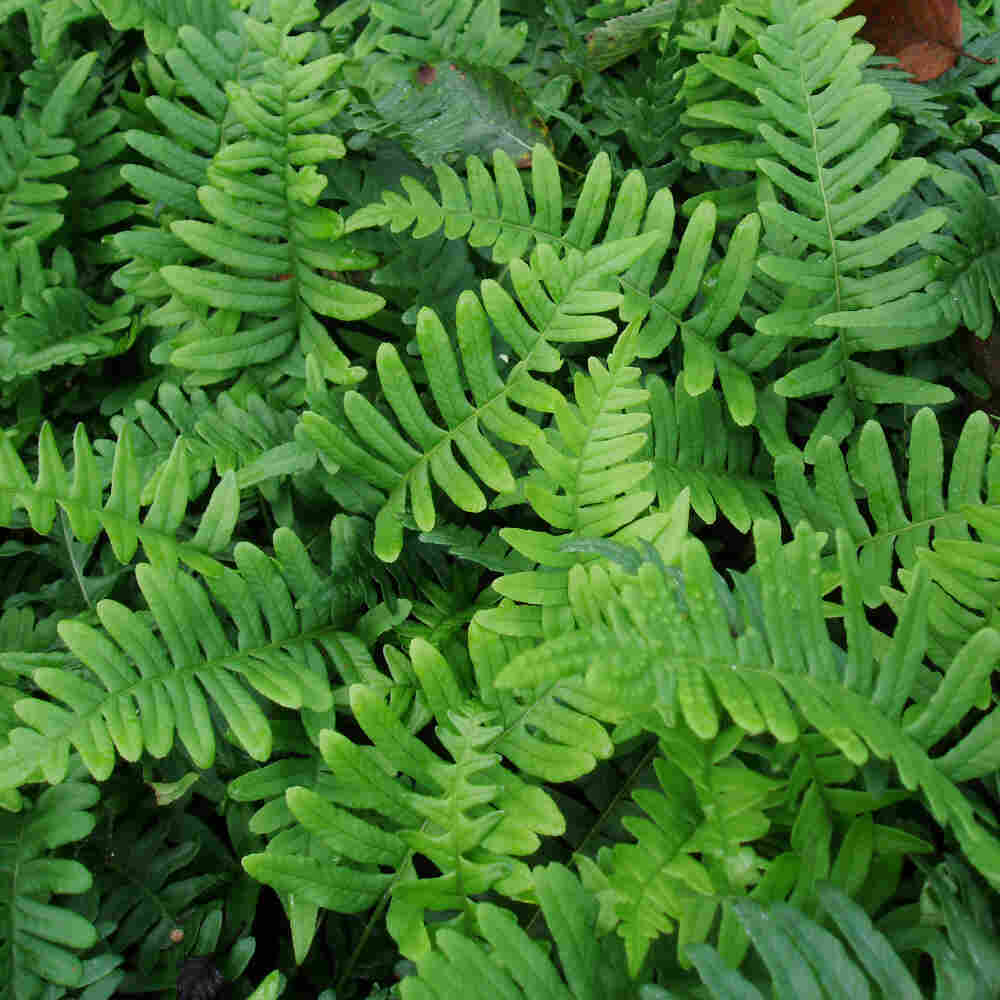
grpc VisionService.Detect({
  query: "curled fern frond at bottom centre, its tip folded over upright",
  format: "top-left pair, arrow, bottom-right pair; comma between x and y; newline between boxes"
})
243,685 -> 562,958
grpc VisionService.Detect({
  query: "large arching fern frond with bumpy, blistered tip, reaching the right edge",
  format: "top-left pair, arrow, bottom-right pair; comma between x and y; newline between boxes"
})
496,521 -> 1000,885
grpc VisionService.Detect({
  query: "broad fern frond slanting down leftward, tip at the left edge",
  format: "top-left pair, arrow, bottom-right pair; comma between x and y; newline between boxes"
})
0,528 -> 392,788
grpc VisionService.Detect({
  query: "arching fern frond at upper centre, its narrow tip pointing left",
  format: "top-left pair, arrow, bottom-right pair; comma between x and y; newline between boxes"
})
347,150 -> 760,426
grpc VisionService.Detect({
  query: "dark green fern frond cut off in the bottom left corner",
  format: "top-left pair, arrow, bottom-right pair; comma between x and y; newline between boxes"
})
0,780 -> 100,1000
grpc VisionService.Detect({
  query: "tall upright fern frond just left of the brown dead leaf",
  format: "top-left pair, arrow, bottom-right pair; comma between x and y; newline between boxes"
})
686,0 -> 953,412
